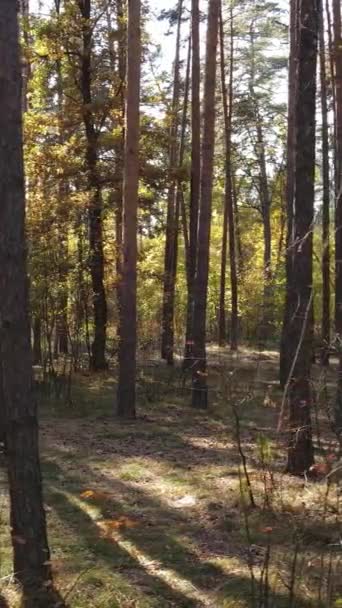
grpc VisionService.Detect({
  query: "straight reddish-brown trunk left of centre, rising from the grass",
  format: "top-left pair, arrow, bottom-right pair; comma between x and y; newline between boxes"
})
117,0 -> 141,418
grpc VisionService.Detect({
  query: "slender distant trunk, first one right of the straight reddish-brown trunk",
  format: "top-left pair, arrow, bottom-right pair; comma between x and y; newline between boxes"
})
161,0 -> 183,365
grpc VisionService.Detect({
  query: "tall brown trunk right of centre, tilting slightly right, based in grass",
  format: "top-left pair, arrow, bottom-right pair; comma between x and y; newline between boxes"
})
192,0 -> 220,408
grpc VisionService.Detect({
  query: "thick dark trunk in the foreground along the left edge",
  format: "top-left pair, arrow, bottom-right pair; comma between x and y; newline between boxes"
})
0,0 -> 63,608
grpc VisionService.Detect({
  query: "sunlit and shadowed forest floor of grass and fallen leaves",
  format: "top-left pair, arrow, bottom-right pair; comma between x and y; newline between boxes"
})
0,349 -> 342,608
